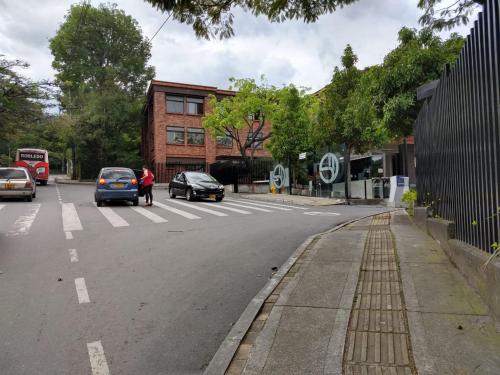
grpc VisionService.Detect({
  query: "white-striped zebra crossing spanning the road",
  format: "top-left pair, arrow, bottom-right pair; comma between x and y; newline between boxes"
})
0,198 -> 307,239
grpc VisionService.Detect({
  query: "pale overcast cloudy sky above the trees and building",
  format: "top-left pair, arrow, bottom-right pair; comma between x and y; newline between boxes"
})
0,0 -> 469,90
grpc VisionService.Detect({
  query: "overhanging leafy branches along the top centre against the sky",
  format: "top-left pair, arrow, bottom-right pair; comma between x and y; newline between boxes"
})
145,0 -> 358,39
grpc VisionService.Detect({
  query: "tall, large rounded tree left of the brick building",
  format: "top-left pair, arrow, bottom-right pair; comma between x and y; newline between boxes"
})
50,4 -> 154,178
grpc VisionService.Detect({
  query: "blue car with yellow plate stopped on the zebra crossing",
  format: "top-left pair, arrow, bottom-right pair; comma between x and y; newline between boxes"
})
94,167 -> 139,207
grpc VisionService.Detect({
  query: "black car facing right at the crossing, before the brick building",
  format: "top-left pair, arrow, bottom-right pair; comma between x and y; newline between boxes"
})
168,172 -> 224,202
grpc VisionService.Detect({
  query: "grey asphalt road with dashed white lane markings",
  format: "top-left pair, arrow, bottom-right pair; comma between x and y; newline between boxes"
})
0,184 -> 382,375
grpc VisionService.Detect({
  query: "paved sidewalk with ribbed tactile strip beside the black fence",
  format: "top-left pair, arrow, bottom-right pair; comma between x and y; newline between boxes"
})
206,211 -> 500,375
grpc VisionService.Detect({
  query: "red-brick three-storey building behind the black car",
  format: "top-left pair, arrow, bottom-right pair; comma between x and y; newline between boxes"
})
141,80 -> 270,182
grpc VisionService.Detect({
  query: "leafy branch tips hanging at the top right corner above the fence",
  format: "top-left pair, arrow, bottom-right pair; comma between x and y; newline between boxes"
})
418,0 -> 485,31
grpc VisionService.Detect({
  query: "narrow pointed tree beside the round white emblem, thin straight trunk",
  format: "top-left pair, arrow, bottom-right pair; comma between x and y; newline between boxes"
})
313,45 -> 386,201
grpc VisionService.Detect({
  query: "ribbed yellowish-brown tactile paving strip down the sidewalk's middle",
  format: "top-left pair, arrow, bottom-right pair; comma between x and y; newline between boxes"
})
343,214 -> 417,375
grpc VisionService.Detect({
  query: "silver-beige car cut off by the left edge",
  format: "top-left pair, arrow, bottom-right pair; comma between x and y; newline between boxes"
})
0,167 -> 36,202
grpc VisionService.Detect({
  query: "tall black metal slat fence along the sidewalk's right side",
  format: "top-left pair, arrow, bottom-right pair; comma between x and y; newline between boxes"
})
415,0 -> 500,252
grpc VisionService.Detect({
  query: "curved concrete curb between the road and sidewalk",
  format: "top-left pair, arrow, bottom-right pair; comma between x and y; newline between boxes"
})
203,209 -> 395,375
